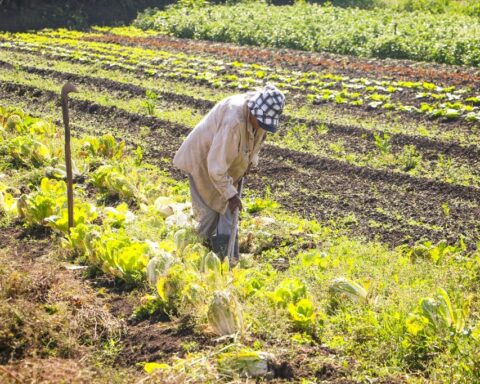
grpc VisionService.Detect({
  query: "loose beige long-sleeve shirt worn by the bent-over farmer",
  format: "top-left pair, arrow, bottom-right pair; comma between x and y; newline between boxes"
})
173,93 -> 266,213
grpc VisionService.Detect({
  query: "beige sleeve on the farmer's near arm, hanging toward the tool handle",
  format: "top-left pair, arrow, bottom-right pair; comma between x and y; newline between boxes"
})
207,123 -> 240,200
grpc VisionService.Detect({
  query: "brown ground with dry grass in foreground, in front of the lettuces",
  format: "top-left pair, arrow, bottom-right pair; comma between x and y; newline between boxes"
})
0,225 -> 352,384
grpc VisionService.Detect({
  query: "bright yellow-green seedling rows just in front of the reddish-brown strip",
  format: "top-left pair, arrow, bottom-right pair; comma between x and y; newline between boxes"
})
0,32 -> 480,122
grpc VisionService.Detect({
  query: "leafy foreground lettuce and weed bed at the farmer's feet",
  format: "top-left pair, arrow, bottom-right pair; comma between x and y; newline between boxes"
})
0,104 -> 480,380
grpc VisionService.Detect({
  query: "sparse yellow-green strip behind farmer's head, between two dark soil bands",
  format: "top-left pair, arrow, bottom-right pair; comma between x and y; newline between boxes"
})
0,56 -> 479,192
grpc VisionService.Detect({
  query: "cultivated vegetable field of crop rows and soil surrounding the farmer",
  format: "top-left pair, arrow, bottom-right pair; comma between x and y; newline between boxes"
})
0,15 -> 480,384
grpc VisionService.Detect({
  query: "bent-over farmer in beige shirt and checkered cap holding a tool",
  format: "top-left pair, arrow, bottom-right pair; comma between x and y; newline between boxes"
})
173,85 -> 285,259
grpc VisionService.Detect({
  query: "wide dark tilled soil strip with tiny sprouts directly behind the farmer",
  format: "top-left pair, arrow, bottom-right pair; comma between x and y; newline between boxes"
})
0,83 -> 480,245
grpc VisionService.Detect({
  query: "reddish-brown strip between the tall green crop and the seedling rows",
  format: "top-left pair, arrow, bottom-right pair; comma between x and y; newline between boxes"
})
83,34 -> 480,86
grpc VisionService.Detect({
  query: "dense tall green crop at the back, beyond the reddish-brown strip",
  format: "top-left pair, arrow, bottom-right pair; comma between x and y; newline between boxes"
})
135,2 -> 480,66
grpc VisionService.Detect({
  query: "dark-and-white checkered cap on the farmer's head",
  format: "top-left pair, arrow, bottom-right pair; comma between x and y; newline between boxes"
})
247,84 -> 285,133
